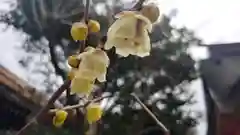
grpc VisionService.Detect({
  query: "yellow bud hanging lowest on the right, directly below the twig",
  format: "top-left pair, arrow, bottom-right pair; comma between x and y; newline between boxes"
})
86,103 -> 103,124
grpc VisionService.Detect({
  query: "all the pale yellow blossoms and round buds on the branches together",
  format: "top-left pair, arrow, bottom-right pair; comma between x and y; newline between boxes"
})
53,4 -> 159,127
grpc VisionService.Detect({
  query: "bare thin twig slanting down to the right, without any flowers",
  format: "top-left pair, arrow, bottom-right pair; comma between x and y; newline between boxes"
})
131,93 -> 170,135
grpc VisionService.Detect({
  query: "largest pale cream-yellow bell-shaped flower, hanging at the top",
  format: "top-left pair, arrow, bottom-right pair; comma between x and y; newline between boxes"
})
104,11 -> 152,57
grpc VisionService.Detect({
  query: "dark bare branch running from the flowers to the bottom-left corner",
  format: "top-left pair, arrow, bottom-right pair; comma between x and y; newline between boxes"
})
16,80 -> 71,135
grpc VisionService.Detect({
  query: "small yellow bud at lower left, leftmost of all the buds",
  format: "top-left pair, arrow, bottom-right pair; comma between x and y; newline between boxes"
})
53,110 -> 68,127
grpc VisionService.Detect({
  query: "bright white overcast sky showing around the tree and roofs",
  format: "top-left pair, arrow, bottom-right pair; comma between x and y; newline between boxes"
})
0,0 -> 240,135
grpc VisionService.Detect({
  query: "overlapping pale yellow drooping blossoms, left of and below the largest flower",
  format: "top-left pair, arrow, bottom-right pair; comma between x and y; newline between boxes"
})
71,47 -> 109,95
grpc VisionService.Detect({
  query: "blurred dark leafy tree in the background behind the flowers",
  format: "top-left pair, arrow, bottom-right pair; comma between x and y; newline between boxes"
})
0,0 -> 200,135
